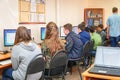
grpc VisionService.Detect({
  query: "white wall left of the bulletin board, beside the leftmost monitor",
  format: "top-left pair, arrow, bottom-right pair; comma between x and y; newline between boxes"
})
0,0 -> 18,50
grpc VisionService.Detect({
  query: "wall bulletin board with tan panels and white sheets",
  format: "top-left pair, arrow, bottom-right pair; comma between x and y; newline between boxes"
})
19,0 -> 45,24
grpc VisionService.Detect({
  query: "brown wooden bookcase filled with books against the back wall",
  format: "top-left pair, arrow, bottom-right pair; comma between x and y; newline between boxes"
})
84,8 -> 104,27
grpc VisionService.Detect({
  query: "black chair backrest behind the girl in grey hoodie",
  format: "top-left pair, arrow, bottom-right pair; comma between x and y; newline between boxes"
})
25,56 -> 45,80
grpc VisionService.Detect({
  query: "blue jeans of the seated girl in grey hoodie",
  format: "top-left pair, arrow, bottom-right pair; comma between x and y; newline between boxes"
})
2,68 -> 14,80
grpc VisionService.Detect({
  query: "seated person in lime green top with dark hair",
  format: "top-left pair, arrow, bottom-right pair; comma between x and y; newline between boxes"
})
89,26 -> 102,50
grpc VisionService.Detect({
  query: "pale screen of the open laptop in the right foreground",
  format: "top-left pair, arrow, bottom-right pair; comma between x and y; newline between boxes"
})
94,46 -> 120,68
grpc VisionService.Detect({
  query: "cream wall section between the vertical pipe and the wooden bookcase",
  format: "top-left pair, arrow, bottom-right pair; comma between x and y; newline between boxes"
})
58,0 -> 88,26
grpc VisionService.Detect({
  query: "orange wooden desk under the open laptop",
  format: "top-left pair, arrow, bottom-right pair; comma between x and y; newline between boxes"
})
82,65 -> 120,80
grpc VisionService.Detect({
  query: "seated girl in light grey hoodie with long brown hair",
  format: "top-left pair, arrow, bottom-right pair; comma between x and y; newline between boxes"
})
2,26 -> 42,80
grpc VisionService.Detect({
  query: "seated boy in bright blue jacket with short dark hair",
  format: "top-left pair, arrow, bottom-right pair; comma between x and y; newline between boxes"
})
78,23 -> 90,45
